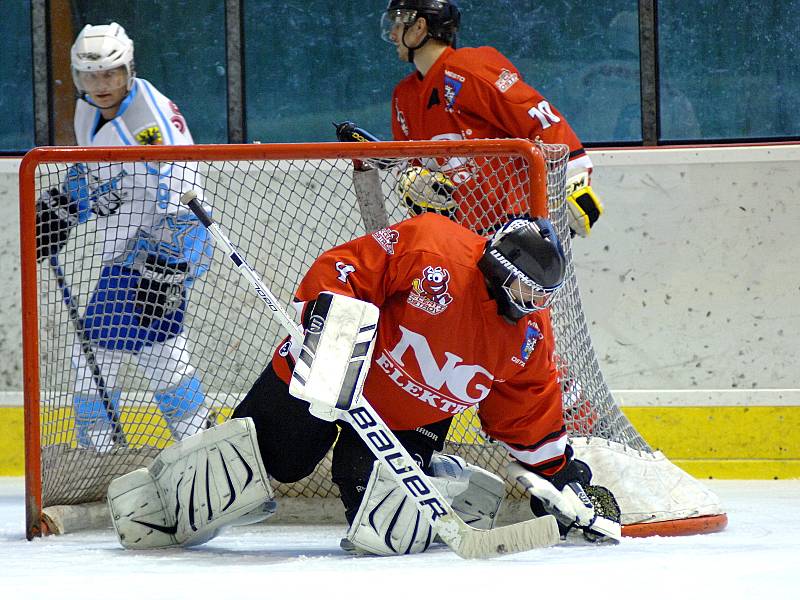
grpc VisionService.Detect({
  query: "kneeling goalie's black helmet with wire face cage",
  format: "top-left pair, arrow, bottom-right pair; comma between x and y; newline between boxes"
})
478,217 -> 566,322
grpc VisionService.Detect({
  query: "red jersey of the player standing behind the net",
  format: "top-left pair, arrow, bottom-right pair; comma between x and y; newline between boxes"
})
391,46 -> 592,230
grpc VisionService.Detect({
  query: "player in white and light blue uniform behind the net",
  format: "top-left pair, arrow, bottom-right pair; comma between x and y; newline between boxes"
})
37,23 -> 211,451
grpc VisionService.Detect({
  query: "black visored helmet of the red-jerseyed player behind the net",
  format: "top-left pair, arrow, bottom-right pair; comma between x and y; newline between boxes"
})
381,0 -> 461,50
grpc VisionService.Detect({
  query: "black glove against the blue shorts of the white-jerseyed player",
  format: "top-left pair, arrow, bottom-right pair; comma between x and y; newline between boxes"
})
136,254 -> 189,327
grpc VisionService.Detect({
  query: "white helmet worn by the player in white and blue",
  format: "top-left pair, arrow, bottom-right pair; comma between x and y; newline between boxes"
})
70,23 -> 135,94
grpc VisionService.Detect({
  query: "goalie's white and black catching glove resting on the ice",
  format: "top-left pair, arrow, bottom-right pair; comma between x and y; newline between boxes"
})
508,446 -> 622,543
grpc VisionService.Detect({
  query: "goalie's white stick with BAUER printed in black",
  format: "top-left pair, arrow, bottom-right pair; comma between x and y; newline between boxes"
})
181,191 -> 559,558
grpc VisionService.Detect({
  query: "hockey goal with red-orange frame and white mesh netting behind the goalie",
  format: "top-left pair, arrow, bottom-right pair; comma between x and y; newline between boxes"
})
20,140 -> 726,539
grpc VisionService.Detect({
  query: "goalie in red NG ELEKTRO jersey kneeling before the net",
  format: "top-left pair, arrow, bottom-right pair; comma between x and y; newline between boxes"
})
225,214 -> 620,555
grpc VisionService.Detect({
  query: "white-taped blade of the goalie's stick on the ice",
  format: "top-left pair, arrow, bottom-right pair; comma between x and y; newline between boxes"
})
440,515 -> 561,558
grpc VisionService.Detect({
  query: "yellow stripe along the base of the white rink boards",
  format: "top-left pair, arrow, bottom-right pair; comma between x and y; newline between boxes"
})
0,406 -> 800,479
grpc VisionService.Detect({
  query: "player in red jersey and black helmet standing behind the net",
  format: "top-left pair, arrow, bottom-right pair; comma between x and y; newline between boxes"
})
383,0 -> 603,236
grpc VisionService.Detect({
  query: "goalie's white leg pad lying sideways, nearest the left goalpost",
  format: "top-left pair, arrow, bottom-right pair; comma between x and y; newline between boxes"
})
107,418 -> 275,548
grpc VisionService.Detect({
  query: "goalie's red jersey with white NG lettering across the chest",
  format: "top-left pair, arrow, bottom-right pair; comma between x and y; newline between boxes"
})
273,214 -> 567,474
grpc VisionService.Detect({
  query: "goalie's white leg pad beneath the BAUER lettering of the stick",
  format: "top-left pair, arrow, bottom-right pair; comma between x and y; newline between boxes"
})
342,462 -> 468,556
